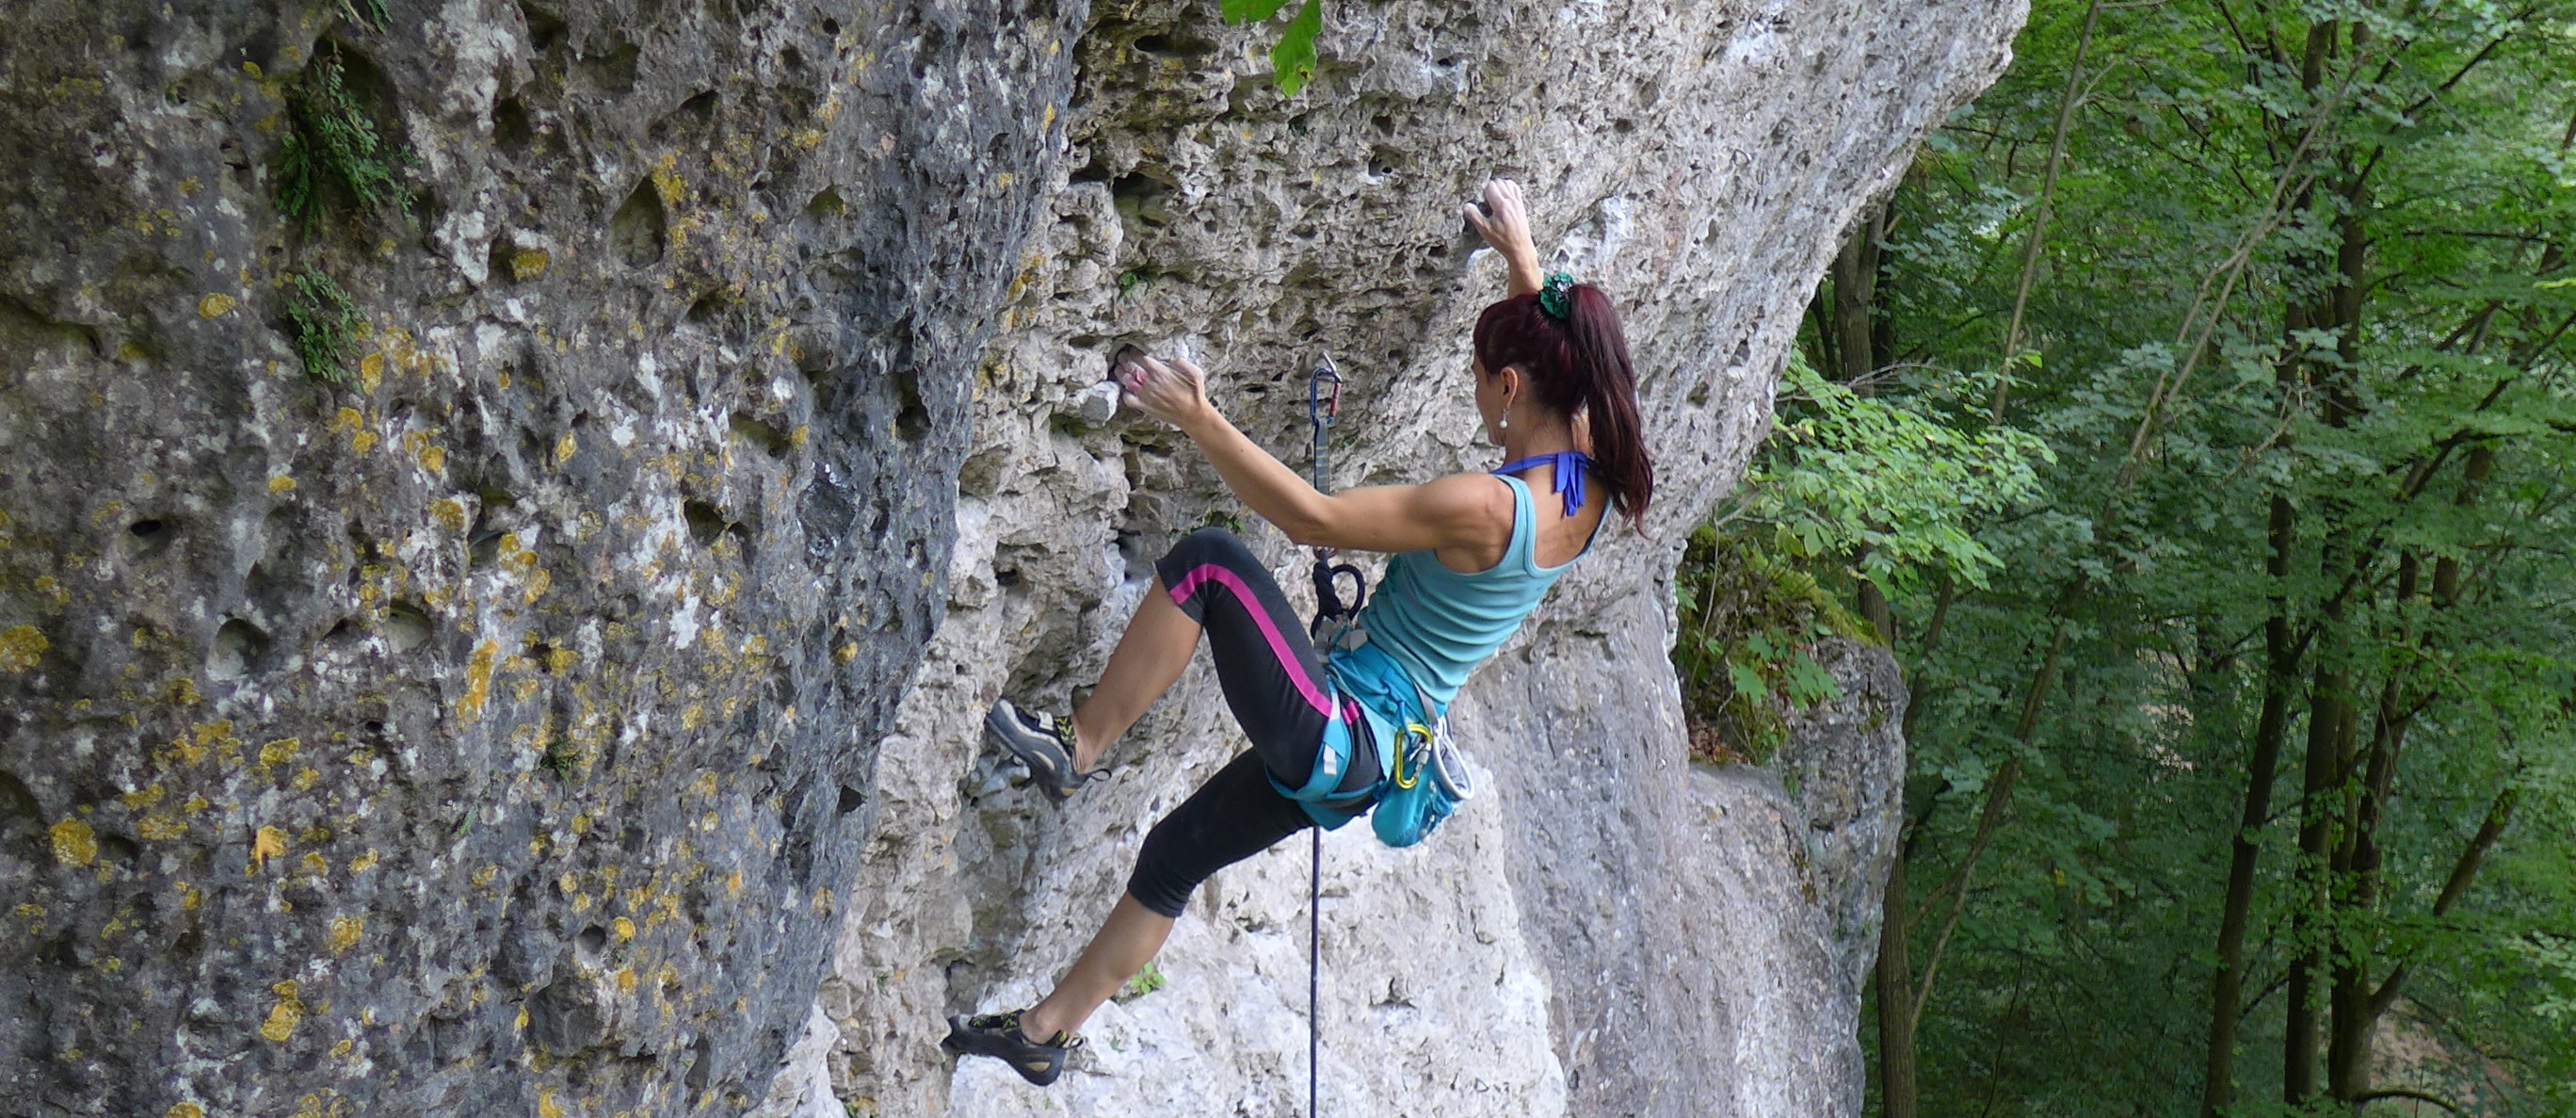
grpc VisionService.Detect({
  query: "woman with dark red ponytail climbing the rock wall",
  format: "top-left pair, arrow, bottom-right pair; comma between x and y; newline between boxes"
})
945,180 -> 1654,1087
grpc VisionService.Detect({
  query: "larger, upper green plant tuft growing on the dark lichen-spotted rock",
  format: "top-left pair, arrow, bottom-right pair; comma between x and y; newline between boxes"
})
276,52 -> 412,229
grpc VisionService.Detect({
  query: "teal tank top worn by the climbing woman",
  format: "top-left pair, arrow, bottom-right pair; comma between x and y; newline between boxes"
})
1360,474 -> 1607,708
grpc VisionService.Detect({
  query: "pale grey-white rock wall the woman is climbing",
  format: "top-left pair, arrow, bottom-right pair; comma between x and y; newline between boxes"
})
825,0 -> 2022,1115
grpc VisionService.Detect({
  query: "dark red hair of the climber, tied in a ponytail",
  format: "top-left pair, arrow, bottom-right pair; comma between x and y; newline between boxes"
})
1476,284 -> 1654,526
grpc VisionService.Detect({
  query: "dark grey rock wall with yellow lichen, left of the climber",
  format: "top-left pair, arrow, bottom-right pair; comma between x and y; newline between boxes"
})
0,0 -> 1085,1118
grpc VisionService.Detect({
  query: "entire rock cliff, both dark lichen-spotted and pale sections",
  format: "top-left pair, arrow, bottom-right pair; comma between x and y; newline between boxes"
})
0,0 -> 2022,1118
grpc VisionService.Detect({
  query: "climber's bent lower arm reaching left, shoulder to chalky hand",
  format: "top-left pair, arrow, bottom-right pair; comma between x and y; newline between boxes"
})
1118,358 -> 1512,551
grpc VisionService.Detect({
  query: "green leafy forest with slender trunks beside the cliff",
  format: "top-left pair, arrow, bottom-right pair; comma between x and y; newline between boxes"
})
1674,0 -> 2576,1118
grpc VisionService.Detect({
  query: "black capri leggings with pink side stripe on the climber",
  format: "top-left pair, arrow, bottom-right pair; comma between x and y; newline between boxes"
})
1128,528 -> 1378,919
